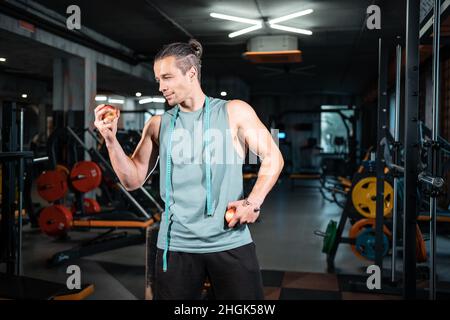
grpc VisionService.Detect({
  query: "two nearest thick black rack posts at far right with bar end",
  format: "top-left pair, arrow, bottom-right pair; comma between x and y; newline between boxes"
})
384,5 -> 447,300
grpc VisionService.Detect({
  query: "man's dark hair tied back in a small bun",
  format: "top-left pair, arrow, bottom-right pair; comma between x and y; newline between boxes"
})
155,39 -> 203,81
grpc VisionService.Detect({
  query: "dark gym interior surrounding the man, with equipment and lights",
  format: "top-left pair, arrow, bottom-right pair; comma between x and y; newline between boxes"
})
0,0 -> 450,300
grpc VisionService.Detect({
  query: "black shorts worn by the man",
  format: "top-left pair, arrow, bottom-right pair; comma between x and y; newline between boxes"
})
154,243 -> 264,300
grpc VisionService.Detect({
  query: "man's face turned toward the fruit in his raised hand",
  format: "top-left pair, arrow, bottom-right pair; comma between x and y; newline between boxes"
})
153,56 -> 192,106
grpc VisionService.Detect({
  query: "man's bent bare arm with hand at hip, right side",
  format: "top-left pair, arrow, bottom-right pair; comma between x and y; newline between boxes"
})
228,100 -> 284,228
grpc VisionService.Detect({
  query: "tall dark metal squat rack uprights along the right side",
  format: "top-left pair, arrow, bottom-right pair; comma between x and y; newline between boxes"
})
376,0 -> 443,300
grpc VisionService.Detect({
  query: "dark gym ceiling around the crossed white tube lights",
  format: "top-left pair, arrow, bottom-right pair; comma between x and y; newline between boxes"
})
0,0 -> 405,99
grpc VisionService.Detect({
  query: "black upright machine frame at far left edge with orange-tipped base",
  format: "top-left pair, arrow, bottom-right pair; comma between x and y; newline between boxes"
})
0,101 -> 94,300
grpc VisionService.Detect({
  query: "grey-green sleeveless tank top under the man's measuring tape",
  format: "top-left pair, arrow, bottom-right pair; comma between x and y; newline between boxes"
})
157,98 -> 252,253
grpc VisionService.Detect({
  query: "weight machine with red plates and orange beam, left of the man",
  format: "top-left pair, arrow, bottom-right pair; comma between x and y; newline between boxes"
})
36,127 -> 162,266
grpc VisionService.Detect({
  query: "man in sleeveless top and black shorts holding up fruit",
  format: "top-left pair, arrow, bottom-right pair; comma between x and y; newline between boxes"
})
95,40 -> 284,299
